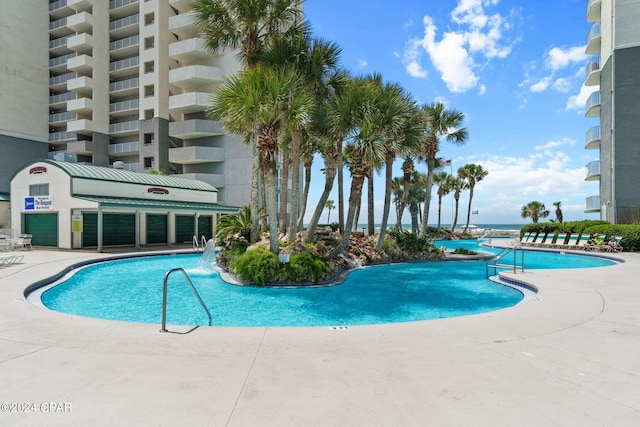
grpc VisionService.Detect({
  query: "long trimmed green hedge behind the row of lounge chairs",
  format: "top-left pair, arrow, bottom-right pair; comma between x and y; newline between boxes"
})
520,220 -> 640,252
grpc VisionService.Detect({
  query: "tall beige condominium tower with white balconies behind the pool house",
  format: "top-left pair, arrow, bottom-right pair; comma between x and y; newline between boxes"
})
0,0 -> 251,211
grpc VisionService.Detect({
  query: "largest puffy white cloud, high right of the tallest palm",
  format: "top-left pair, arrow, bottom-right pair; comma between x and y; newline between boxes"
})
403,0 -> 511,94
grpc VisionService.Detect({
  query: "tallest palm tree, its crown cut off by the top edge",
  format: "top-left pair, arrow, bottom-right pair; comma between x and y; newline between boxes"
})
192,0 -> 303,242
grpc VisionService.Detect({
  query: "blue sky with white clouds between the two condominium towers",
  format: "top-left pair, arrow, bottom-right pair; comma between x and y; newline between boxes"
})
305,0 -> 598,224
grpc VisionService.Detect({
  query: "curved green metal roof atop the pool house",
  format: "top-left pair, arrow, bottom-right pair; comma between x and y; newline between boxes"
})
22,160 -> 218,192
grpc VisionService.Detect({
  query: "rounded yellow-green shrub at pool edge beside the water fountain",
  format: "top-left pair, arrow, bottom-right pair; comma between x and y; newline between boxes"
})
231,247 -> 280,286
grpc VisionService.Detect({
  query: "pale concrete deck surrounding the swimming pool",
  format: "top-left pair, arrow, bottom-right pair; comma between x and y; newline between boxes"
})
0,250 -> 640,426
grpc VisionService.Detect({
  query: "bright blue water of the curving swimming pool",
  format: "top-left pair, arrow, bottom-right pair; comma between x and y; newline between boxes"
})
41,241 -> 611,326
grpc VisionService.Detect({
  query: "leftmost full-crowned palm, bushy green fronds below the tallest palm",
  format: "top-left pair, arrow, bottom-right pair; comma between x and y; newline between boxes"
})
209,66 -> 312,253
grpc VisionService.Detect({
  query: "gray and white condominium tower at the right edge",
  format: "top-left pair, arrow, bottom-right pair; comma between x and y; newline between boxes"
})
585,0 -> 640,223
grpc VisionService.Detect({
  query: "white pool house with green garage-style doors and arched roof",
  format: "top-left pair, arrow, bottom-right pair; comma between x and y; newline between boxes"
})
11,160 -> 238,251
